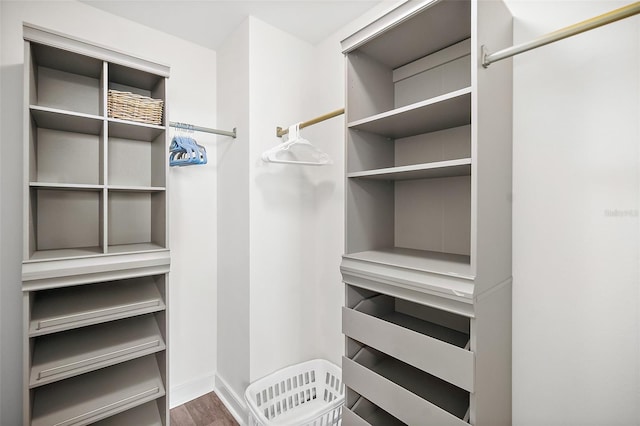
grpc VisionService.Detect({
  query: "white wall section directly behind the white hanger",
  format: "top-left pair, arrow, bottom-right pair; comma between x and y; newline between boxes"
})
248,18 -> 315,380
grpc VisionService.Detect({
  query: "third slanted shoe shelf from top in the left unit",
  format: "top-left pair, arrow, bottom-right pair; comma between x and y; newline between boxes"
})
31,355 -> 165,426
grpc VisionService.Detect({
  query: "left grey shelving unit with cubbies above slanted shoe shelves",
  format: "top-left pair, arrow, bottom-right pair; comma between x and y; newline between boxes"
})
22,24 -> 170,426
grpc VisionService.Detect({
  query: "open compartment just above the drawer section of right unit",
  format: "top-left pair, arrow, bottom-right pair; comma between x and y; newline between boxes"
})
346,176 -> 471,260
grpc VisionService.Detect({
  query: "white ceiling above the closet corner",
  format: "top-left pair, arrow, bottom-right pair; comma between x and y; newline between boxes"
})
81,0 -> 389,50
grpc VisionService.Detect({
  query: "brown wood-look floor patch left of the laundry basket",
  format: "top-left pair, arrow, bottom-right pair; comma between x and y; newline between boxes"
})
171,392 -> 239,426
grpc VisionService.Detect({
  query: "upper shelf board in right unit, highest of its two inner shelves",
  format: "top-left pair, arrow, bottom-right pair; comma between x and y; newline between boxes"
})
348,87 -> 471,139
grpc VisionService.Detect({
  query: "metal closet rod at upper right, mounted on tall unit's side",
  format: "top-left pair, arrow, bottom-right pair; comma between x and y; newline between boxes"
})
482,2 -> 640,68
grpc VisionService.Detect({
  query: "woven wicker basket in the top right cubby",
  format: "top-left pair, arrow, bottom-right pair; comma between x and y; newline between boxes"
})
107,89 -> 163,124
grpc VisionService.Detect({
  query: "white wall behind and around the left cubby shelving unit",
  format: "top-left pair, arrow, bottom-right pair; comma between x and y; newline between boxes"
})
0,1 -> 217,425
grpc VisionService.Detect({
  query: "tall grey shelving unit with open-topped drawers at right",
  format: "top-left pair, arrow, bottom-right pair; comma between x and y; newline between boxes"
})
341,0 -> 512,426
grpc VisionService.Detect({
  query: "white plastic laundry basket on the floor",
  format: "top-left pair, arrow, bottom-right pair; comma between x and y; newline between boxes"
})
244,359 -> 344,426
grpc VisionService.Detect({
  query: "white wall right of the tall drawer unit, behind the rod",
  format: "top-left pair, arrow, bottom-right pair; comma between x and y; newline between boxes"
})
508,1 -> 640,426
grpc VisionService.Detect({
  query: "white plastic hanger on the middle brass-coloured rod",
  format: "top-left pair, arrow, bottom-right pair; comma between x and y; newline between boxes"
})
262,123 -> 331,166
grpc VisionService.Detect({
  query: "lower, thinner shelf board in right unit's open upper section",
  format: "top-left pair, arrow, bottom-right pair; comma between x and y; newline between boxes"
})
347,158 -> 471,180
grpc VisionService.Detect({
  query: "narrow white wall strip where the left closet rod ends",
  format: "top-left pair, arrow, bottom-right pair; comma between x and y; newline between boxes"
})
216,16 -> 250,417
